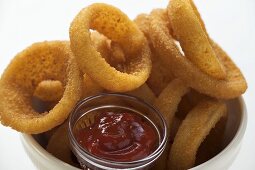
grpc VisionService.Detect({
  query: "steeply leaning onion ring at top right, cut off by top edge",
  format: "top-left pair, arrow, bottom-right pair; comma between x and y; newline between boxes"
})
167,0 -> 226,79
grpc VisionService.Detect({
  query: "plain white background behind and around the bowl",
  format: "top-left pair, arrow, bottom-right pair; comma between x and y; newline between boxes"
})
0,0 -> 255,170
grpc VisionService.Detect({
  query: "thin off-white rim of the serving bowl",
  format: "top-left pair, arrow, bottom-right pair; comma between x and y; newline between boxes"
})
20,96 -> 248,170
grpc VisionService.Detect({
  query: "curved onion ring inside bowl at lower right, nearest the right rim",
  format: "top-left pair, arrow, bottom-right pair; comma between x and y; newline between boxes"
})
168,100 -> 227,170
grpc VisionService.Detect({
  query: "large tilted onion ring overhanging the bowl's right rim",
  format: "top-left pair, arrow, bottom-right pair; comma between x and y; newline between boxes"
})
150,9 -> 247,99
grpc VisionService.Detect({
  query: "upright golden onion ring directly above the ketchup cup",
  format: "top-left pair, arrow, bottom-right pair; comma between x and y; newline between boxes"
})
69,3 -> 151,92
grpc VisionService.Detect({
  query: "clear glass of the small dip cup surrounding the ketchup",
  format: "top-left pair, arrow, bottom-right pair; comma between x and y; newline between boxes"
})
68,93 -> 167,170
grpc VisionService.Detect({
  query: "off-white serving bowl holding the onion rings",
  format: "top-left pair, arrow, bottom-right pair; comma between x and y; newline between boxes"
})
21,97 -> 247,170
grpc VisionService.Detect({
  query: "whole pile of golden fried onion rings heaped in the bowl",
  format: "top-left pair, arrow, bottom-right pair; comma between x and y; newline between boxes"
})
0,0 -> 247,169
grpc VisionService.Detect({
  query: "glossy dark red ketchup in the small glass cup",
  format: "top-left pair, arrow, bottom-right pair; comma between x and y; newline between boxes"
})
75,111 -> 159,162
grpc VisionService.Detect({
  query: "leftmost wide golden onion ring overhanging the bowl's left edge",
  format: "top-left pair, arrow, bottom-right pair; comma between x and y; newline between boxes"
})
0,41 -> 81,134
